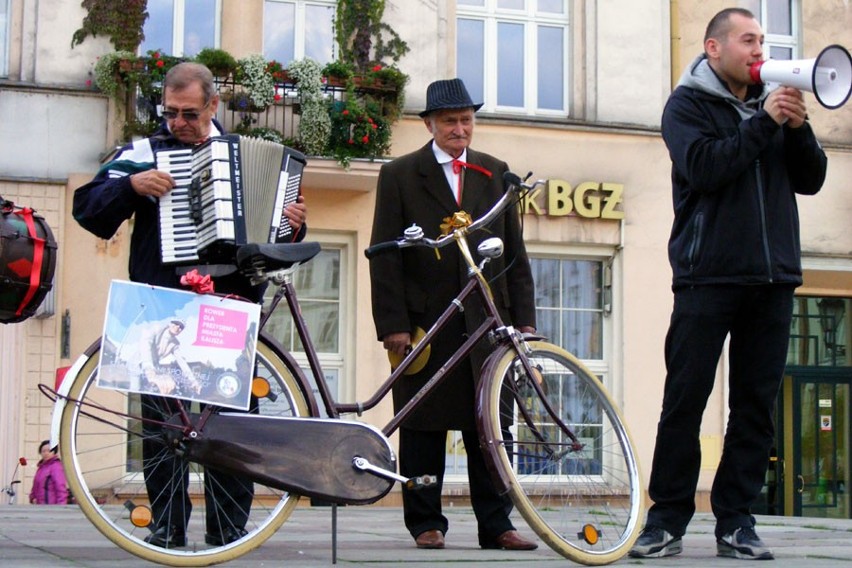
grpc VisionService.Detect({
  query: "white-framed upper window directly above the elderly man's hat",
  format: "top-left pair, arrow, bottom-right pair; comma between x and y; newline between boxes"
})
456,0 -> 570,116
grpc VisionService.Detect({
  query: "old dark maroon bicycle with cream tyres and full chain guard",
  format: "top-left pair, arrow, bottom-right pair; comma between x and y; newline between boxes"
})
42,174 -> 644,566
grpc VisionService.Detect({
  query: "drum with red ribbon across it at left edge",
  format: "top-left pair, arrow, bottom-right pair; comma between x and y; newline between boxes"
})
0,198 -> 57,323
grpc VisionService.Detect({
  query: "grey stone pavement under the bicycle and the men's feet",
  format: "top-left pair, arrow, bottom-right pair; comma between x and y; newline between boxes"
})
0,505 -> 852,568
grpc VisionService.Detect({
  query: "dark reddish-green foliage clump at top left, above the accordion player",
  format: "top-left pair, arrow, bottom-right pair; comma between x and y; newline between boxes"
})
71,0 -> 148,52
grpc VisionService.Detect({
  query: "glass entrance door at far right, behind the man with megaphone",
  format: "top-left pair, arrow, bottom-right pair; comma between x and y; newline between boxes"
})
781,367 -> 852,519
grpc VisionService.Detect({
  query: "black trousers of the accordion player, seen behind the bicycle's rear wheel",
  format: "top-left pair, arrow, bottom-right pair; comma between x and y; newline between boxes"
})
141,395 -> 256,536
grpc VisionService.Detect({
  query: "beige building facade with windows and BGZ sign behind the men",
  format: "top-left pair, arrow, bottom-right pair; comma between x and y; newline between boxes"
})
0,0 -> 852,517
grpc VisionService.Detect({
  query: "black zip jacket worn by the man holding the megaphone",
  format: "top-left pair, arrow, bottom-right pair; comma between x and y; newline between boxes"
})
662,86 -> 827,289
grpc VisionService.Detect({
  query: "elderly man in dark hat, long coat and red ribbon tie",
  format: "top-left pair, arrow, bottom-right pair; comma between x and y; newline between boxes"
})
370,79 -> 537,550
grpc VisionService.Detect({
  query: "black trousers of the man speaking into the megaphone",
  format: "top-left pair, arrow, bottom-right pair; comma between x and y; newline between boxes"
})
647,285 -> 794,537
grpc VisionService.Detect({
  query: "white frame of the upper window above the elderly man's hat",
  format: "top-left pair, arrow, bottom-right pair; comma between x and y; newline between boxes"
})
456,0 -> 573,118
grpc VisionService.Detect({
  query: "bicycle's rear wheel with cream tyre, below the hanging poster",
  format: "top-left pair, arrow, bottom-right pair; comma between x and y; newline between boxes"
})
59,338 -> 309,566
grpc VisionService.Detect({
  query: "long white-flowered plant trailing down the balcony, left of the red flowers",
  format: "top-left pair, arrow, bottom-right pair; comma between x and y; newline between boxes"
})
287,57 -> 331,156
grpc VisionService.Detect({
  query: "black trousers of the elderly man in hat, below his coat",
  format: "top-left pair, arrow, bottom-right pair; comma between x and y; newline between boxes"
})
399,428 -> 514,545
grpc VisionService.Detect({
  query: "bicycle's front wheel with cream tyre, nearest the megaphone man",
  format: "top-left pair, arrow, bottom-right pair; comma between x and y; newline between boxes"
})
479,342 -> 643,565
